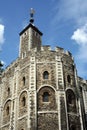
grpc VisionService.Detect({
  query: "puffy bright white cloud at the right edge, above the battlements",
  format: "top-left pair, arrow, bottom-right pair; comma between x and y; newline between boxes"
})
71,24 -> 87,62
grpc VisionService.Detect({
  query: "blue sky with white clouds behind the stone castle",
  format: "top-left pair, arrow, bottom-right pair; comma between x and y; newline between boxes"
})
0,0 -> 87,79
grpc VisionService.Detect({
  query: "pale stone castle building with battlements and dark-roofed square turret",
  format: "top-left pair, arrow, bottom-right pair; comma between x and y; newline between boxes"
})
0,12 -> 87,130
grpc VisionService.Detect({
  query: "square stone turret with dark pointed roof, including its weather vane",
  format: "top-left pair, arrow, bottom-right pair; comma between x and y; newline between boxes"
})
19,8 -> 42,57
